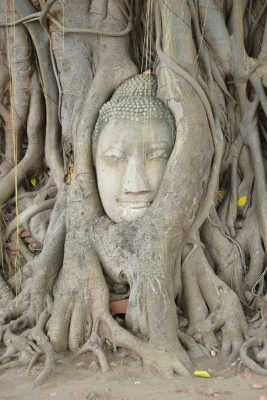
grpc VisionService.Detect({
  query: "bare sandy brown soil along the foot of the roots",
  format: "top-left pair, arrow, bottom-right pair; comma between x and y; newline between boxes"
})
0,350 -> 267,400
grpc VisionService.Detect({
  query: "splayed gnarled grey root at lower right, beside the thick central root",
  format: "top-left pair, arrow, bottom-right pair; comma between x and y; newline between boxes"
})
182,246 -> 247,359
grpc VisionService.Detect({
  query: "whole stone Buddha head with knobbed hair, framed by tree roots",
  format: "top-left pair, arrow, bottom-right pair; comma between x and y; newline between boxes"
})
93,74 -> 175,223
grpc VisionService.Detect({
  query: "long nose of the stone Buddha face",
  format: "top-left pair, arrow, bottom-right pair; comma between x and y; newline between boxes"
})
122,156 -> 151,194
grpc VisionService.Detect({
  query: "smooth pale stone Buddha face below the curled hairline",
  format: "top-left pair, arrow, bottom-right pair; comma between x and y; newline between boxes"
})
95,119 -> 173,223
